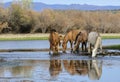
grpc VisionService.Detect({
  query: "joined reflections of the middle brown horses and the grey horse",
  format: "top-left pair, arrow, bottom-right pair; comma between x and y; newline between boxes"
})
64,60 -> 102,80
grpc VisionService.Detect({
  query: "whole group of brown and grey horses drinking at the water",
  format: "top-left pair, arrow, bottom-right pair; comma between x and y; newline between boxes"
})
49,29 -> 102,57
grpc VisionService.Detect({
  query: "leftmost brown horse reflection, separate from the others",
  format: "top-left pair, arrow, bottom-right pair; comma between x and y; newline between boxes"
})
49,60 -> 62,76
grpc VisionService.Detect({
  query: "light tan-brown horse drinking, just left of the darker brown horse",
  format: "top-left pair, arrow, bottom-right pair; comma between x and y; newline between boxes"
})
62,30 -> 80,53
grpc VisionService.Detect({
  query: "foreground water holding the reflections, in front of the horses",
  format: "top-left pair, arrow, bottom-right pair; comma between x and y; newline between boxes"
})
0,55 -> 120,82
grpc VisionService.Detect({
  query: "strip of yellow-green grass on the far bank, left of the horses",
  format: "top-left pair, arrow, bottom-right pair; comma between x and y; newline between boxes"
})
0,34 -> 49,41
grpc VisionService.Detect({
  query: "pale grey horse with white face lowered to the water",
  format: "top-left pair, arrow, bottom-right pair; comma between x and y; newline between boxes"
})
88,32 -> 102,57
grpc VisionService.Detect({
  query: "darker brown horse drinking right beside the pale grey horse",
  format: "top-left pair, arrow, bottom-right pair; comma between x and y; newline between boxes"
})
73,30 -> 88,51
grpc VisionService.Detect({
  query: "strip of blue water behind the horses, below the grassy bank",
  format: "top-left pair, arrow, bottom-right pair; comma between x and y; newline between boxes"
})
0,39 -> 120,49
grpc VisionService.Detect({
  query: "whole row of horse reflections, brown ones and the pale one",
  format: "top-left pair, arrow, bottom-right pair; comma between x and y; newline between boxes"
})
49,60 -> 102,80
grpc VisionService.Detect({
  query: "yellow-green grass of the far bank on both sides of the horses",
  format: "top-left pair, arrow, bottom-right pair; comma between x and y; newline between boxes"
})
0,33 -> 120,41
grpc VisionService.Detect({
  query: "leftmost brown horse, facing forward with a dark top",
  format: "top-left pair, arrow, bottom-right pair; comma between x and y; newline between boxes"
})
49,29 -> 60,54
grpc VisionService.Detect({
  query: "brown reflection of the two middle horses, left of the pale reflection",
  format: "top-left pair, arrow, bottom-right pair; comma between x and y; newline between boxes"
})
63,60 -> 88,75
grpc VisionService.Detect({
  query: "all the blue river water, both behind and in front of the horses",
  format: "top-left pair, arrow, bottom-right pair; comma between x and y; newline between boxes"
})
0,39 -> 120,82
